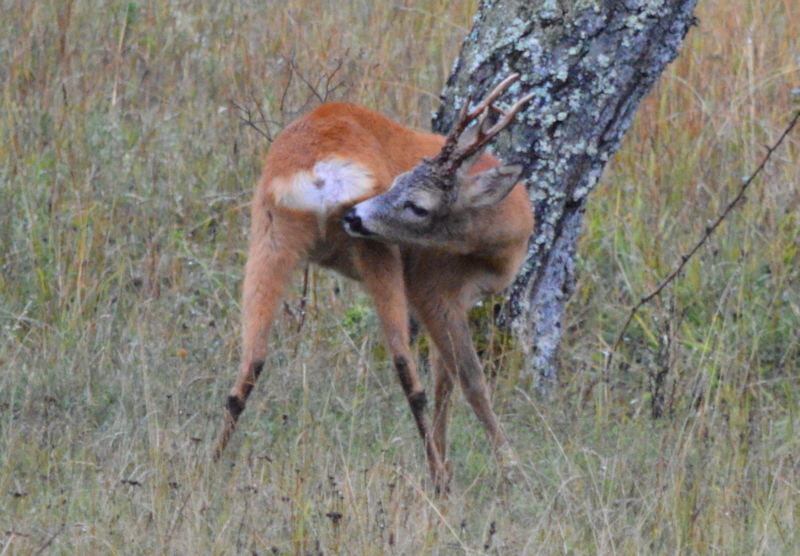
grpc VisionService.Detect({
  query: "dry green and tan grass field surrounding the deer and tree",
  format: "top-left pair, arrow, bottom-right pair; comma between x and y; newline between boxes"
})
0,0 -> 800,555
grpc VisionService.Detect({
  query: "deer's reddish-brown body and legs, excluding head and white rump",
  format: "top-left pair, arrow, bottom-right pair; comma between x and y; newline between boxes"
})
216,103 -> 533,487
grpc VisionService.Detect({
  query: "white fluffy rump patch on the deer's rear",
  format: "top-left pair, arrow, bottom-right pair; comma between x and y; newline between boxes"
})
272,158 -> 375,217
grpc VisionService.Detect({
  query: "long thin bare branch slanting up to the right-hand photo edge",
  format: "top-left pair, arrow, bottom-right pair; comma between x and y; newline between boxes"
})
604,111 -> 800,374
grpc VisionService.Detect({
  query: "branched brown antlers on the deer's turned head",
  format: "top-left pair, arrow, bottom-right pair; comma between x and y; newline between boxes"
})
435,73 -> 536,170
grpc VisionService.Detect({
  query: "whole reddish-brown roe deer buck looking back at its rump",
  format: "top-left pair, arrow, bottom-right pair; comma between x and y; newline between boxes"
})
214,75 -> 533,492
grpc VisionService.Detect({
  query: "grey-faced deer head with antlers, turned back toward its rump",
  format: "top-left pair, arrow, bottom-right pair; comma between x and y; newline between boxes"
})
344,75 -> 534,246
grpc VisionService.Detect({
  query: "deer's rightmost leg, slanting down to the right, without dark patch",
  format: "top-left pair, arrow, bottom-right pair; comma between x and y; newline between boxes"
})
421,303 -> 517,478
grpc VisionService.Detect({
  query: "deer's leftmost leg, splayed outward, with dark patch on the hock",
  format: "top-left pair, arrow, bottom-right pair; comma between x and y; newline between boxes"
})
214,217 -> 307,460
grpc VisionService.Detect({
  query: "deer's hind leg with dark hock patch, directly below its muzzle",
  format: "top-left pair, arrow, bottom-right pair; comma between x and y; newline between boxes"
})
358,242 -> 449,492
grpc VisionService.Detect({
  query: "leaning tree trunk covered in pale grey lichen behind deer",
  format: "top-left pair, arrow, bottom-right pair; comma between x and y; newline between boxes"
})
433,0 -> 696,377
